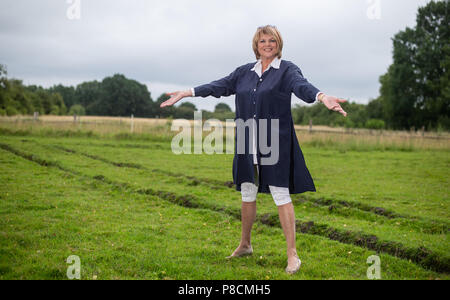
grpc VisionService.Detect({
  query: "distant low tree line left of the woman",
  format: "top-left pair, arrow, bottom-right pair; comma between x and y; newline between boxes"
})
0,64 -> 234,120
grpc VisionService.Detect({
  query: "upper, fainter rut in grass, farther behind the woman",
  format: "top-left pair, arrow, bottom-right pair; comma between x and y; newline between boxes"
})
40,141 -> 449,234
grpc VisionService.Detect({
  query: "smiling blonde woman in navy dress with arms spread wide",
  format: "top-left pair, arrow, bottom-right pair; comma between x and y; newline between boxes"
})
161,25 -> 347,274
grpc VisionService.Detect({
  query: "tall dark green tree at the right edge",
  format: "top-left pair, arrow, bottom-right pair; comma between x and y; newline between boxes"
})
380,1 -> 450,129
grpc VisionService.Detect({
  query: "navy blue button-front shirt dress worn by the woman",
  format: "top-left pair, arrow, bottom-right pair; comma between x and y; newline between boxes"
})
194,60 -> 319,194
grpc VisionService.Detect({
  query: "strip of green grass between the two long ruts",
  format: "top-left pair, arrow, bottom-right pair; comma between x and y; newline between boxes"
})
15,141 -> 448,257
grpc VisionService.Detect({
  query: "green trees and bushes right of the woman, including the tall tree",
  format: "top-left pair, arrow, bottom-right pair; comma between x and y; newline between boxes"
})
293,1 -> 450,130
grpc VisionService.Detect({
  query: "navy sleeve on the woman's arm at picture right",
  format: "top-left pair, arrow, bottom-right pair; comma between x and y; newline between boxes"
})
287,64 -> 320,103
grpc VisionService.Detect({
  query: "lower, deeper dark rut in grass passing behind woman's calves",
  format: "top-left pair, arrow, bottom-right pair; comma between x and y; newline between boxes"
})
0,143 -> 450,274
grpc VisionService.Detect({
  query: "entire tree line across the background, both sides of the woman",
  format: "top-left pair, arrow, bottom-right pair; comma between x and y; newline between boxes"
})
0,1 -> 450,130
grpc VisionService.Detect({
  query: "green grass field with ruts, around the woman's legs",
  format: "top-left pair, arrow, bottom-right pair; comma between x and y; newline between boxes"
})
0,116 -> 450,279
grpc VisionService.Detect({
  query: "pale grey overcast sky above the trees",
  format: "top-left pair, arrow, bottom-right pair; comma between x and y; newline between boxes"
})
0,0 -> 436,110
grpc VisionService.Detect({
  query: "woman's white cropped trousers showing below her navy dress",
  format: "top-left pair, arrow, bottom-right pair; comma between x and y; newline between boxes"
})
241,165 -> 292,206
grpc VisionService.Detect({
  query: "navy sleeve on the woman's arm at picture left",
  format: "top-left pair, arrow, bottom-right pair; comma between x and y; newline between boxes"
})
193,68 -> 243,98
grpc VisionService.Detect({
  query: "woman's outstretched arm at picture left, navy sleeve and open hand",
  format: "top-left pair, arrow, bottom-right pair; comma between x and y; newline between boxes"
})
160,68 -> 239,107
